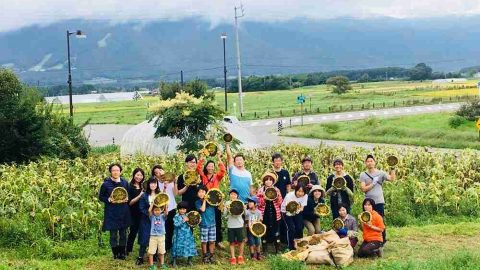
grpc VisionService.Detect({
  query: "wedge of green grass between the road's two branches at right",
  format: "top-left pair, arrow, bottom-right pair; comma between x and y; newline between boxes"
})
282,113 -> 480,149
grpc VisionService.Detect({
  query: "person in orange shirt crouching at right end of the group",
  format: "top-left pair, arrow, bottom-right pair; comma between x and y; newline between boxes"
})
358,198 -> 385,257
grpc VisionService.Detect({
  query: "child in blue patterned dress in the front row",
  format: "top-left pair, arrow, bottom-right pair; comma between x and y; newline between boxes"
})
172,201 -> 197,268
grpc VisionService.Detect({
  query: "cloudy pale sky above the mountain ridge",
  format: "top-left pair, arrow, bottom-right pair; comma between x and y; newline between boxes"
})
0,0 -> 480,32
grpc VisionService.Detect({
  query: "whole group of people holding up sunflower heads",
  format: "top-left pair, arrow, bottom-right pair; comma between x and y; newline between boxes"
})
99,143 -> 395,269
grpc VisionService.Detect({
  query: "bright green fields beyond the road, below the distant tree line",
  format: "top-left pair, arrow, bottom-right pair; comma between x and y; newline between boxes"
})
54,78 -> 476,124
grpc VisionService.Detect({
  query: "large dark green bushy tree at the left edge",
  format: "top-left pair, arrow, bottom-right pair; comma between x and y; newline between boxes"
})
0,70 -> 90,163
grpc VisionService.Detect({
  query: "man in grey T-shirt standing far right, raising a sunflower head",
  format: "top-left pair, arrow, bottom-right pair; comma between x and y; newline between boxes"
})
360,155 -> 396,244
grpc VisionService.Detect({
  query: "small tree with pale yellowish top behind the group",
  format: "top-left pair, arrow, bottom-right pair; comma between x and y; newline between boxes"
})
150,92 -> 223,152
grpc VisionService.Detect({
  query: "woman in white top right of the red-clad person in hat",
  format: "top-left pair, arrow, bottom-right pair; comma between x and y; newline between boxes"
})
280,185 -> 308,250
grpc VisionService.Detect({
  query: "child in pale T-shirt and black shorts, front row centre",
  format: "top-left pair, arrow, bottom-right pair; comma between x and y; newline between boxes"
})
223,189 -> 245,265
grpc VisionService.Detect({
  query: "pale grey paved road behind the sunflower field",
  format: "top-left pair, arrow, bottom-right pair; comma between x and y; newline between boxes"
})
84,103 -> 461,148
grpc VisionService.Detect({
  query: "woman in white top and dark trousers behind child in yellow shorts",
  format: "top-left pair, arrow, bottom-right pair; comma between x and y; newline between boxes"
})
151,165 -> 178,251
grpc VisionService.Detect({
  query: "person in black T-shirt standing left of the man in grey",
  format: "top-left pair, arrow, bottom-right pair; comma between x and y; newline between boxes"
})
325,159 -> 354,219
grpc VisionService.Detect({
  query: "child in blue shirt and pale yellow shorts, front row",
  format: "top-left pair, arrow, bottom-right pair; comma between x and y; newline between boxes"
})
148,203 -> 168,270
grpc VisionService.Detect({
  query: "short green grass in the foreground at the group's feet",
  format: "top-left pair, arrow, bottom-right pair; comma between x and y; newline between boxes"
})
0,223 -> 480,270
